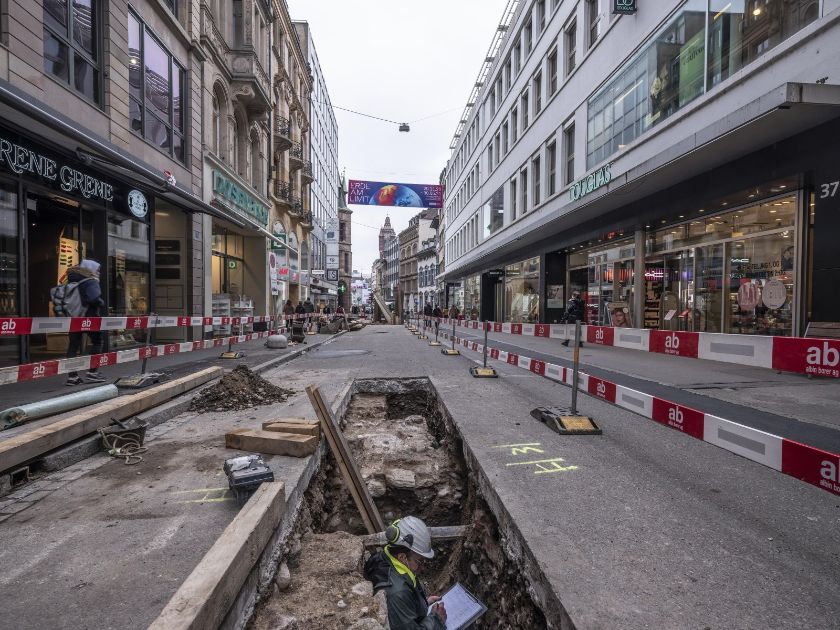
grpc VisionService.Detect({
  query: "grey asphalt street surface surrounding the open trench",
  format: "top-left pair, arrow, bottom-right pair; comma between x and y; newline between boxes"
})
0,326 -> 840,629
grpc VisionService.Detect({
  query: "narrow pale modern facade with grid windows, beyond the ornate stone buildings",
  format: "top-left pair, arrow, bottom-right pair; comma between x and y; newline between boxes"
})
295,22 -> 339,308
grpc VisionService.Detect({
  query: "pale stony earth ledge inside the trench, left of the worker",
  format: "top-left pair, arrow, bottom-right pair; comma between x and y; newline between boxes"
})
253,532 -> 385,630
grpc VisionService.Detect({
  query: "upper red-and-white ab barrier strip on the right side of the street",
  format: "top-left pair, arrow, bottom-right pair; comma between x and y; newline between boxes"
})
424,319 -> 840,378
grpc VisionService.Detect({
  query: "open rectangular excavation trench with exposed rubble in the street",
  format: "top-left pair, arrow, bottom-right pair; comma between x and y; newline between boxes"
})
251,379 -> 547,630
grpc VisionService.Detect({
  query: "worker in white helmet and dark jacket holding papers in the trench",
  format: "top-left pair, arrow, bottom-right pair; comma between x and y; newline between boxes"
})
364,516 -> 446,630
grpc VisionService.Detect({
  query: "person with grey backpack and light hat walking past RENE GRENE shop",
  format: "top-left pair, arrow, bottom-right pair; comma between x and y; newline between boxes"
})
60,258 -> 106,385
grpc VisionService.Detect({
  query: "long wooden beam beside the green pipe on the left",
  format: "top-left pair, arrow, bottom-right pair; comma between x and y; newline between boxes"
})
0,367 -> 224,471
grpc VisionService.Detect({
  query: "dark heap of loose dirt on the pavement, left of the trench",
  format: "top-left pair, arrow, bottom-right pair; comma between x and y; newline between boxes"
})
190,365 -> 294,412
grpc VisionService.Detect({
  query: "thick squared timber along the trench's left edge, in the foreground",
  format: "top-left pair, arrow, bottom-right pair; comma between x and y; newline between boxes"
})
149,481 -> 286,630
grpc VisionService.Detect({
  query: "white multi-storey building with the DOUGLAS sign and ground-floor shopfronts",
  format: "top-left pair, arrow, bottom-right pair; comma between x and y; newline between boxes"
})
444,0 -> 840,335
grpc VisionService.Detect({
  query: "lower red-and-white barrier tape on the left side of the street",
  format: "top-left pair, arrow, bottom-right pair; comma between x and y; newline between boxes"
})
0,328 -> 296,385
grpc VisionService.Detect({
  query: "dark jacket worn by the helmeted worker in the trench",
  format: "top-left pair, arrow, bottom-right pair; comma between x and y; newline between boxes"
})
364,551 -> 446,630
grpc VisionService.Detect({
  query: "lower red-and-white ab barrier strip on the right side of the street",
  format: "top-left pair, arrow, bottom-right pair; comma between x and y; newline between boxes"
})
434,322 -> 840,496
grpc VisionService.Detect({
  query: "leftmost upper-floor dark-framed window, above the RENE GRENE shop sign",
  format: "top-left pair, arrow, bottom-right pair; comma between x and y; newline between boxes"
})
44,0 -> 102,104
